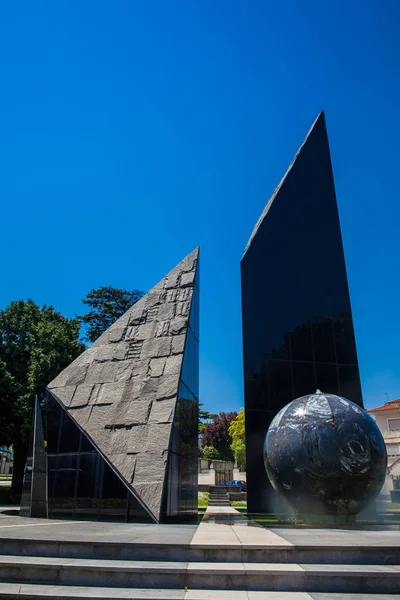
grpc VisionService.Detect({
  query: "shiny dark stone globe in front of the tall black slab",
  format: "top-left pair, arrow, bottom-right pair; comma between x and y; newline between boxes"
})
264,390 -> 387,515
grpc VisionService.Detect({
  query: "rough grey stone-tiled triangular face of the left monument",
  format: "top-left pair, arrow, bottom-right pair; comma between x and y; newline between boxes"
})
48,249 -> 198,520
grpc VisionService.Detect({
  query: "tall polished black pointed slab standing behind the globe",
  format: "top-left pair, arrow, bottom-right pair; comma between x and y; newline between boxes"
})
241,114 -> 362,512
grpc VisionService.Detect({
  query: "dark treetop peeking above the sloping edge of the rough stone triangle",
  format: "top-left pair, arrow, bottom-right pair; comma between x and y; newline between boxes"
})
77,286 -> 144,342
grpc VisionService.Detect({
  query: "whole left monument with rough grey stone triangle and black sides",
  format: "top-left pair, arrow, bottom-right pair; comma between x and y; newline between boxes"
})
47,249 -> 199,522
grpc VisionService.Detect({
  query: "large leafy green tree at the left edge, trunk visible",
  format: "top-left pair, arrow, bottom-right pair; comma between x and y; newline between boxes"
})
0,300 -> 84,493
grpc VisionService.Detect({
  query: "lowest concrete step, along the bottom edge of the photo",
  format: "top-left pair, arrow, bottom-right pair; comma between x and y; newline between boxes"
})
0,583 -> 400,600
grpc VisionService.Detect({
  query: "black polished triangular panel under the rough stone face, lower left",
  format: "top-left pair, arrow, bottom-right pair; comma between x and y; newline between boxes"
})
47,393 -> 151,522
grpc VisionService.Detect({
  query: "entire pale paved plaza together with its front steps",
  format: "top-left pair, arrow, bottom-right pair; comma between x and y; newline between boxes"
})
0,507 -> 400,600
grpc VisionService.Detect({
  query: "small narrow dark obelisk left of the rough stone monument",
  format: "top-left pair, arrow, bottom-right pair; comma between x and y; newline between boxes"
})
20,396 -> 47,519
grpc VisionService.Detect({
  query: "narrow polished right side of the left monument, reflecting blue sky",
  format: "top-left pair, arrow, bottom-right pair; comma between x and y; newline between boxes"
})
163,266 -> 199,522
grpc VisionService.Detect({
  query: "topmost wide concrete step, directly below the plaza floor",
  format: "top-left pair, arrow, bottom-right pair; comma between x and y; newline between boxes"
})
0,537 -> 400,565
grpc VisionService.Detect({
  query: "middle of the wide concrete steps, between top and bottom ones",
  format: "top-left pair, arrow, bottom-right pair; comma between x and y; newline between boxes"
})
0,556 -> 400,594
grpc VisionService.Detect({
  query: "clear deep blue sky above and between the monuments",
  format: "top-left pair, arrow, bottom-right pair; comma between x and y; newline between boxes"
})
0,0 -> 400,411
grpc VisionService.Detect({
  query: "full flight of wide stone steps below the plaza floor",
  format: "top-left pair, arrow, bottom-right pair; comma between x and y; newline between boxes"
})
0,538 -> 400,600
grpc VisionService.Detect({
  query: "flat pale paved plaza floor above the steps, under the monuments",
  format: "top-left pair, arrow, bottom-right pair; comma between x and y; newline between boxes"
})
0,507 -> 400,549
